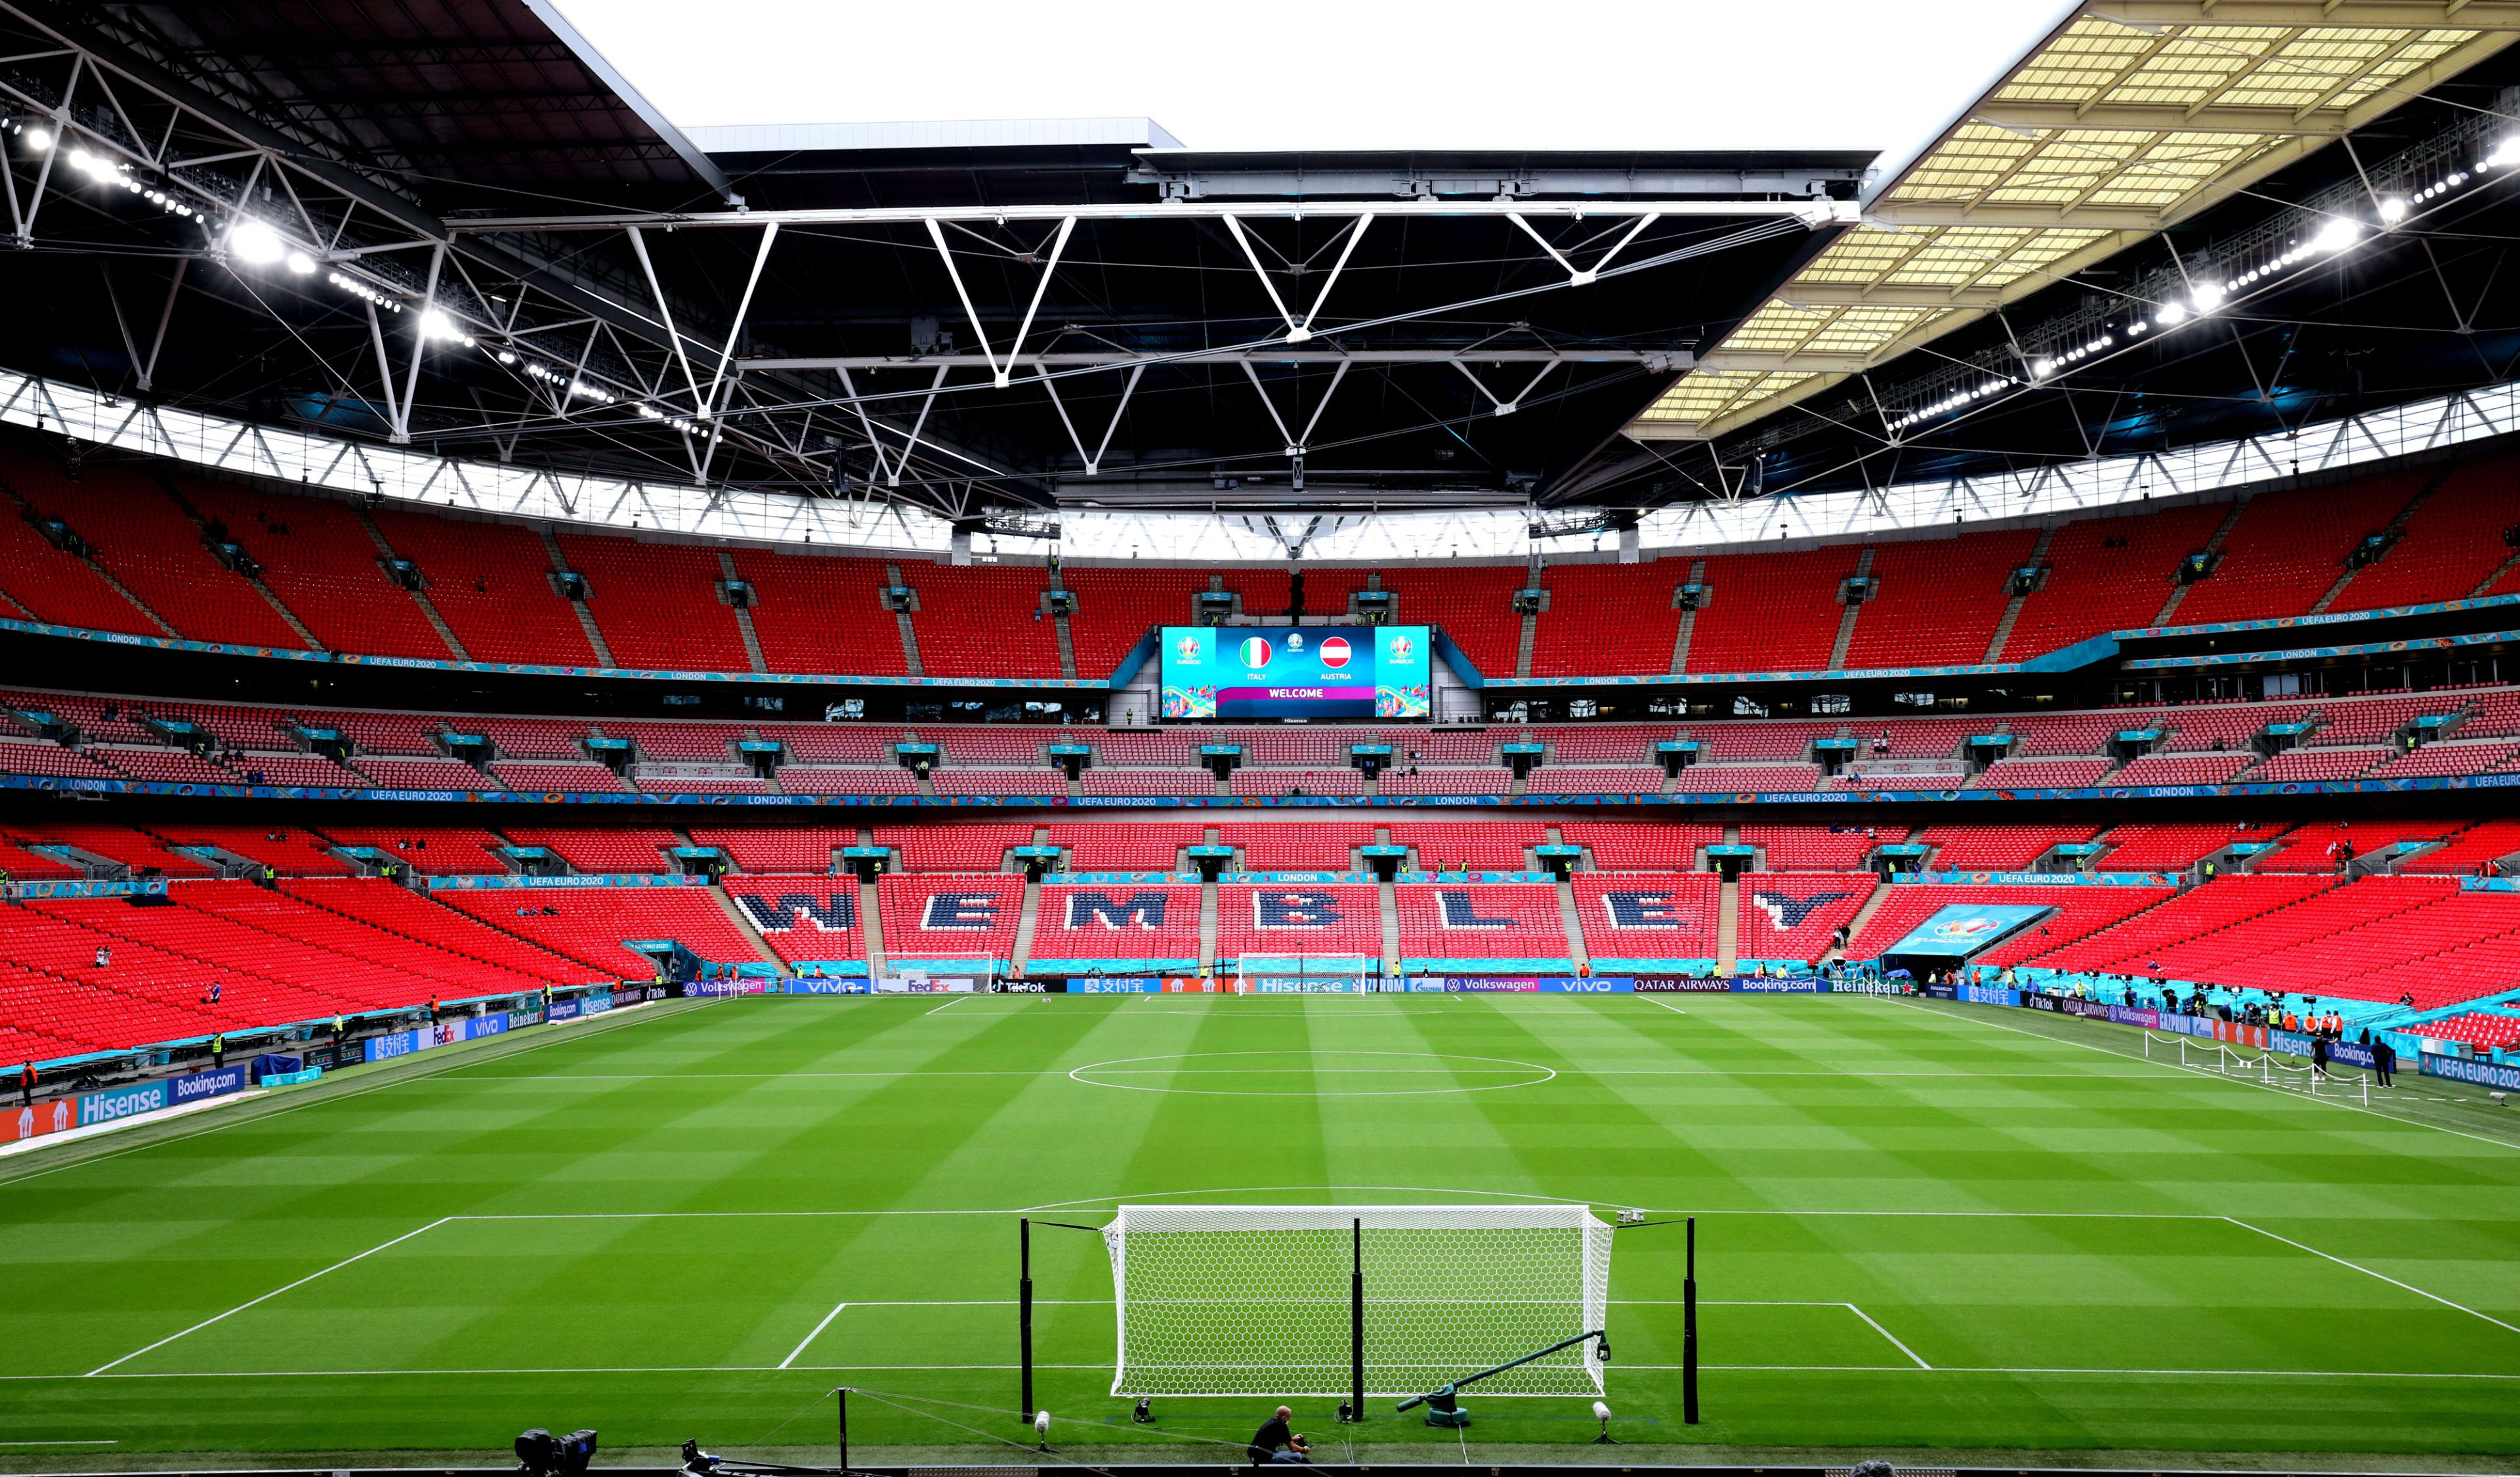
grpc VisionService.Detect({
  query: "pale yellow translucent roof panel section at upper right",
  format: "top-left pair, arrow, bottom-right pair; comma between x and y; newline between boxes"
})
1630,0 -> 2520,439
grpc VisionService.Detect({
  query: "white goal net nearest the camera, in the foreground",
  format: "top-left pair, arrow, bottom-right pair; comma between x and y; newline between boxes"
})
1104,1205 -> 1613,1396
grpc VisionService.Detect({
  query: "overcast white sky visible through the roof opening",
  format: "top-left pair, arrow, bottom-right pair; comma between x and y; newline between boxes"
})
562,0 -> 2061,151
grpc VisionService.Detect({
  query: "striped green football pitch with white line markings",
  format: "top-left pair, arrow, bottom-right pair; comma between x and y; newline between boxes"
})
0,996 -> 2520,1469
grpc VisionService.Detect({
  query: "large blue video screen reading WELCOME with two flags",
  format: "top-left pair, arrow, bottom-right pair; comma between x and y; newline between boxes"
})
1164,625 -> 1434,718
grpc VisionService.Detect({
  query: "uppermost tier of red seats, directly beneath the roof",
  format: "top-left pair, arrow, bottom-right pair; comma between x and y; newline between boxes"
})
14,436 -> 2512,678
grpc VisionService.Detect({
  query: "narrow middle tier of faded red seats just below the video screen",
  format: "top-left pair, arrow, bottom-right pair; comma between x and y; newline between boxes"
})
20,685 -> 2520,802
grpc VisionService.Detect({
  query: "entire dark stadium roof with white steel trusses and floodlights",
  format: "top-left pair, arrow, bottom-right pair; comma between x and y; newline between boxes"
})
0,0 -> 2520,532
